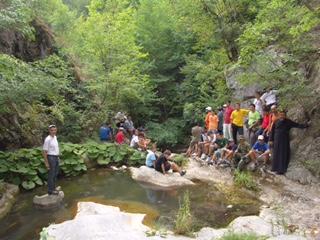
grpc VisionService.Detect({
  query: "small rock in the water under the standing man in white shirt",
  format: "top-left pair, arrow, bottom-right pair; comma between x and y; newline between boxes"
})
33,191 -> 64,209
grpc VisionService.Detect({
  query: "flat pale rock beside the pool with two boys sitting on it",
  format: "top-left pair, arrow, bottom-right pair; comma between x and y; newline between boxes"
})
130,166 -> 195,189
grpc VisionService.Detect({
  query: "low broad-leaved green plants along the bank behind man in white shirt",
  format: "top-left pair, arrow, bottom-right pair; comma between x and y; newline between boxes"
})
0,143 -> 145,190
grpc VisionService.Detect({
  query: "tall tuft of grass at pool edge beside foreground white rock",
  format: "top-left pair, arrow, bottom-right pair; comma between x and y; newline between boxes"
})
174,191 -> 193,236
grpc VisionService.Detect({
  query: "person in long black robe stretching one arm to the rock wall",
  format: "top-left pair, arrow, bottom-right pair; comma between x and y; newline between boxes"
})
269,111 -> 308,174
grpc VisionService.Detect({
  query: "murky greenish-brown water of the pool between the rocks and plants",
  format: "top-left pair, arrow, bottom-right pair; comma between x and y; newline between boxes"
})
0,169 -> 259,240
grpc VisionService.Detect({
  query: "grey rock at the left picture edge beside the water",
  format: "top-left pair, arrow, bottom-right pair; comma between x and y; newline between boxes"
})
0,183 -> 19,219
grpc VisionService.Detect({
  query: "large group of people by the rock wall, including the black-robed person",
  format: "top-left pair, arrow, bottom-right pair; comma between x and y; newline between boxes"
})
186,89 -> 309,174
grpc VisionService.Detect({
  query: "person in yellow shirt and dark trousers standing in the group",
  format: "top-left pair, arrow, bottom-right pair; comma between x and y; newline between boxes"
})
230,103 -> 249,144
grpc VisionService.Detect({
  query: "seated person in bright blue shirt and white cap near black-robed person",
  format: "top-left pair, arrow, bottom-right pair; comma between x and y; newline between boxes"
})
247,135 -> 270,167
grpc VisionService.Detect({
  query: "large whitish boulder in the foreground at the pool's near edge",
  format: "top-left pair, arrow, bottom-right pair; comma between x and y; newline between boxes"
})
46,202 -> 190,240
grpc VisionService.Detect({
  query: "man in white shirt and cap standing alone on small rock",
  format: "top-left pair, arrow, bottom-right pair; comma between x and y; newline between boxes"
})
43,125 -> 60,195
